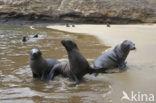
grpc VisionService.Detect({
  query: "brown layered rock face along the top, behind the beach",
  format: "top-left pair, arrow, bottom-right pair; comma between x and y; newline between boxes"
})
0,0 -> 156,23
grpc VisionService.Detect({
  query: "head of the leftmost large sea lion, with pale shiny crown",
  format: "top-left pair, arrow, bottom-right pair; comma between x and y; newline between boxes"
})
30,49 -> 42,60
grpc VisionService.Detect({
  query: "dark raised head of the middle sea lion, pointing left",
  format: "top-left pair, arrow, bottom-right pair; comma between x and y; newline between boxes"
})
61,40 -> 78,51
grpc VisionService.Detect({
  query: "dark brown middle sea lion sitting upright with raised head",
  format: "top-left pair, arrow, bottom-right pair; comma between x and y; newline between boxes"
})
50,40 -> 95,86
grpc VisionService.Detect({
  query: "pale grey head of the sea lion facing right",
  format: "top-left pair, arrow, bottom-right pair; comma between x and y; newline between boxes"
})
121,40 -> 136,51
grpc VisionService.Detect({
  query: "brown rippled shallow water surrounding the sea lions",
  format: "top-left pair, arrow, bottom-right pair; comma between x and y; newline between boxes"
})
0,25 -> 112,103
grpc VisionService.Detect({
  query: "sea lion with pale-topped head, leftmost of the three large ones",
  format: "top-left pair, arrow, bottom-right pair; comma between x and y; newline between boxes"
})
30,49 -> 59,81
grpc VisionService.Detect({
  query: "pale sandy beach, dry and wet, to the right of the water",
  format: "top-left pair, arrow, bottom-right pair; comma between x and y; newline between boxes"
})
47,24 -> 156,103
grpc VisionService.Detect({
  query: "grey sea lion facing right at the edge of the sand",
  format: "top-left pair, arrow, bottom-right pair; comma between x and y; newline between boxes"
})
94,40 -> 136,73
